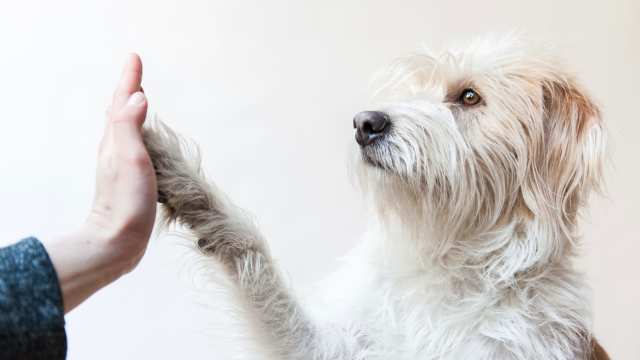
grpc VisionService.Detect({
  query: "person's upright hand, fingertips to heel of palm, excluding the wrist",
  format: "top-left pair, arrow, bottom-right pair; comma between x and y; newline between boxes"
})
85,54 -> 157,271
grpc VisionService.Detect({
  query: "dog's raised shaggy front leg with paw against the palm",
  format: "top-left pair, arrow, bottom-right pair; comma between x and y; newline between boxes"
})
144,122 -> 365,360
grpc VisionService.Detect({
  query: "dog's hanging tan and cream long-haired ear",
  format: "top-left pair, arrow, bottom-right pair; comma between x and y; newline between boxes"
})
529,73 -> 605,230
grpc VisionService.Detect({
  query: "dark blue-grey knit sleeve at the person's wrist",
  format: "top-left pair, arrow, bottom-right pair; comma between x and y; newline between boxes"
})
0,238 -> 67,360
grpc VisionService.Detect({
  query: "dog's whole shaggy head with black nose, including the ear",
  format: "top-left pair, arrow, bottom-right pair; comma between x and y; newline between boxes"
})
354,39 -> 604,249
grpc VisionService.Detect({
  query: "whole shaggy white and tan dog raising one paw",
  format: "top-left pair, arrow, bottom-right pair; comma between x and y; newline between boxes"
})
145,38 -> 606,360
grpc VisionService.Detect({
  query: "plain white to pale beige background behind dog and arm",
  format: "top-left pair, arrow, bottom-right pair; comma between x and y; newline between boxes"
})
0,0 -> 640,360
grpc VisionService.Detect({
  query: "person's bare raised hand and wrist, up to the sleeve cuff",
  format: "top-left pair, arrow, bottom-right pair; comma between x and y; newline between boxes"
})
45,54 -> 157,312
